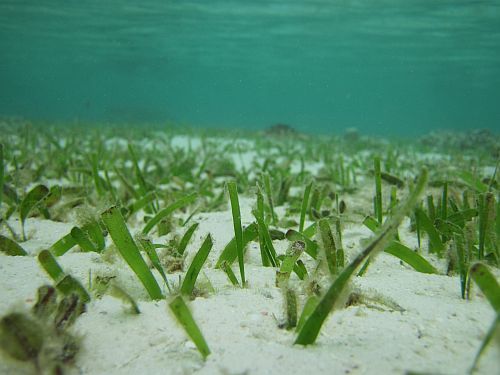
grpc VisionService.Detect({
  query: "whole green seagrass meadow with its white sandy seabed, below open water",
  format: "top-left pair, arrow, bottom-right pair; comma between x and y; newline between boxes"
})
0,118 -> 500,374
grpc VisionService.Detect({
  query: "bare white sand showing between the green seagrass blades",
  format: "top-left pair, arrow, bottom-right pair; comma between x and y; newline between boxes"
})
0,137 -> 500,375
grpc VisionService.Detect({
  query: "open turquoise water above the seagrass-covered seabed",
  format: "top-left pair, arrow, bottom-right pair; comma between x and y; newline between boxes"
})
0,0 -> 500,136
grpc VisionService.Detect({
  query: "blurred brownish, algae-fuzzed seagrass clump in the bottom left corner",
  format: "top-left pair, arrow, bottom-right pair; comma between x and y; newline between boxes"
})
0,285 -> 85,374
